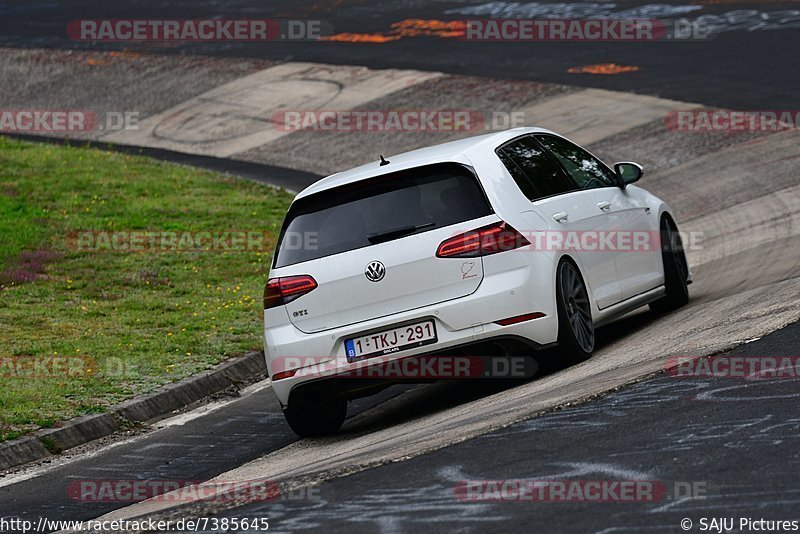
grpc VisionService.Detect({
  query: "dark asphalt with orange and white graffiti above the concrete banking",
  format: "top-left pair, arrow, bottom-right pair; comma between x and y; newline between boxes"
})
0,0 -> 800,109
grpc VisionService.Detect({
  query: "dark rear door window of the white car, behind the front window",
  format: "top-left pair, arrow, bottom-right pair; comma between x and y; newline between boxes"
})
497,136 -> 575,200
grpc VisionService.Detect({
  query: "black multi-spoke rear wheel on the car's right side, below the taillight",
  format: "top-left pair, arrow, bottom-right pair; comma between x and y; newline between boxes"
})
556,260 -> 594,363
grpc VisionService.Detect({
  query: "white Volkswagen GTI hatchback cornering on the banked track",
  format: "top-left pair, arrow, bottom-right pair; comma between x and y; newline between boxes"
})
264,128 -> 691,436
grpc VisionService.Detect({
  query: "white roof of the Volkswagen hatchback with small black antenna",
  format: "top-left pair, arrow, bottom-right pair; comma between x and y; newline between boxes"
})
295,127 -> 552,199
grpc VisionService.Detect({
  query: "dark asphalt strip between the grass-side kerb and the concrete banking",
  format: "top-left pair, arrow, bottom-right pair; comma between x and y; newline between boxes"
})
0,386 -> 418,532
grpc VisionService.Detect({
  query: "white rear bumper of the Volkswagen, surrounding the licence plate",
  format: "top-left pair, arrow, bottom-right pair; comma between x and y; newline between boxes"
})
264,260 -> 558,406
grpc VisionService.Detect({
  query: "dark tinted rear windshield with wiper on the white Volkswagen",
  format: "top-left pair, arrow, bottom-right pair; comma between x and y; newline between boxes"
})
274,163 -> 492,267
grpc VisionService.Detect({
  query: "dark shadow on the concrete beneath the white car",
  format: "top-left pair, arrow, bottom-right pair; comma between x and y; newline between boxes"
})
339,308 -> 661,437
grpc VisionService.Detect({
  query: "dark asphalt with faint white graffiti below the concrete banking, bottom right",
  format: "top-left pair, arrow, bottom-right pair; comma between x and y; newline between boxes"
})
219,323 -> 800,532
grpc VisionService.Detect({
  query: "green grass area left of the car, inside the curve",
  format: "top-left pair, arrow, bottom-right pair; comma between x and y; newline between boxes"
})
0,137 -> 291,440
